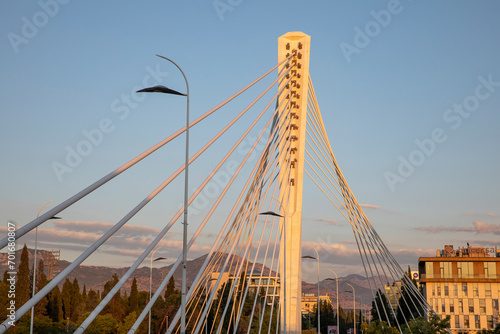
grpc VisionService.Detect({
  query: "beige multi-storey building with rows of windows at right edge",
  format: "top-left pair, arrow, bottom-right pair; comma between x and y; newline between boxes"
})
419,245 -> 500,333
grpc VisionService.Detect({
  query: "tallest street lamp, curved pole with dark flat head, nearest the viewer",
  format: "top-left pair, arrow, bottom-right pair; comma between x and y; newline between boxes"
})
137,55 -> 189,334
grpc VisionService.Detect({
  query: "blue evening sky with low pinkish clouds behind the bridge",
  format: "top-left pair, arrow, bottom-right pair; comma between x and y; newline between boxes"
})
0,0 -> 500,280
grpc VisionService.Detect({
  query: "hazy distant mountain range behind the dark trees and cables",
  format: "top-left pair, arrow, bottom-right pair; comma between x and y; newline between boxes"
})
0,249 -> 384,309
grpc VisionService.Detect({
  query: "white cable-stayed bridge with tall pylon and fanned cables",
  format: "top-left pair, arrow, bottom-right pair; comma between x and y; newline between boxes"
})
0,32 -> 442,334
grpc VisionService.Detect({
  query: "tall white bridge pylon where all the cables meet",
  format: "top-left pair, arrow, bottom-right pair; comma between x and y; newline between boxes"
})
278,32 -> 311,334
